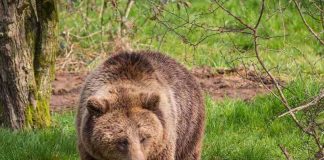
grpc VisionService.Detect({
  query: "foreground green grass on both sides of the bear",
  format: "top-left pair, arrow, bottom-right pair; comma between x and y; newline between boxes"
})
0,81 -> 323,160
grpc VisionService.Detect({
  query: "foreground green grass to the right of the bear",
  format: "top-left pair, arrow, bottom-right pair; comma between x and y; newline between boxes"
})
203,78 -> 324,160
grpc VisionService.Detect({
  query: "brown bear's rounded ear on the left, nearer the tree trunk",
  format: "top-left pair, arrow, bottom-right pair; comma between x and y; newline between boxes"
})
87,96 -> 109,116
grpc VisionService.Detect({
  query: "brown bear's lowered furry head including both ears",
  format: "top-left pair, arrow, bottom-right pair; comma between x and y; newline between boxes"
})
81,88 -> 165,160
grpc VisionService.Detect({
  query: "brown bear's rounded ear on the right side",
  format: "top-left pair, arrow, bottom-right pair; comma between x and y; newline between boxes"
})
140,93 -> 160,110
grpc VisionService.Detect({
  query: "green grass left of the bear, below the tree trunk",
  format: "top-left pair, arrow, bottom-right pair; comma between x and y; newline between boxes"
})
0,113 -> 78,160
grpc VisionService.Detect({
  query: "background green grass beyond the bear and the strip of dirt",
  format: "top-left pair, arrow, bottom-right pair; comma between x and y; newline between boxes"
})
60,0 -> 324,76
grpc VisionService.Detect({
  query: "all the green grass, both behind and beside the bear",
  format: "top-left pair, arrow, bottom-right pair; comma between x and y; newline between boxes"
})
0,0 -> 324,160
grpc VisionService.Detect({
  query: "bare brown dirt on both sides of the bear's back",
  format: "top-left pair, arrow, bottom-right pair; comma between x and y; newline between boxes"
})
51,67 -> 274,112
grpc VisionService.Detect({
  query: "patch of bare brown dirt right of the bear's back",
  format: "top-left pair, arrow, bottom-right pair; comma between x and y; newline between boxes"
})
192,67 -> 274,100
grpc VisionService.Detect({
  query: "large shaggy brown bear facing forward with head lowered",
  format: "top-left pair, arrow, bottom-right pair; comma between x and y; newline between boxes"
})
77,51 -> 205,160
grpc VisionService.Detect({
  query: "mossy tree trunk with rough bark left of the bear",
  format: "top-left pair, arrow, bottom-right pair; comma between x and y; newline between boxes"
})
0,0 -> 58,129
